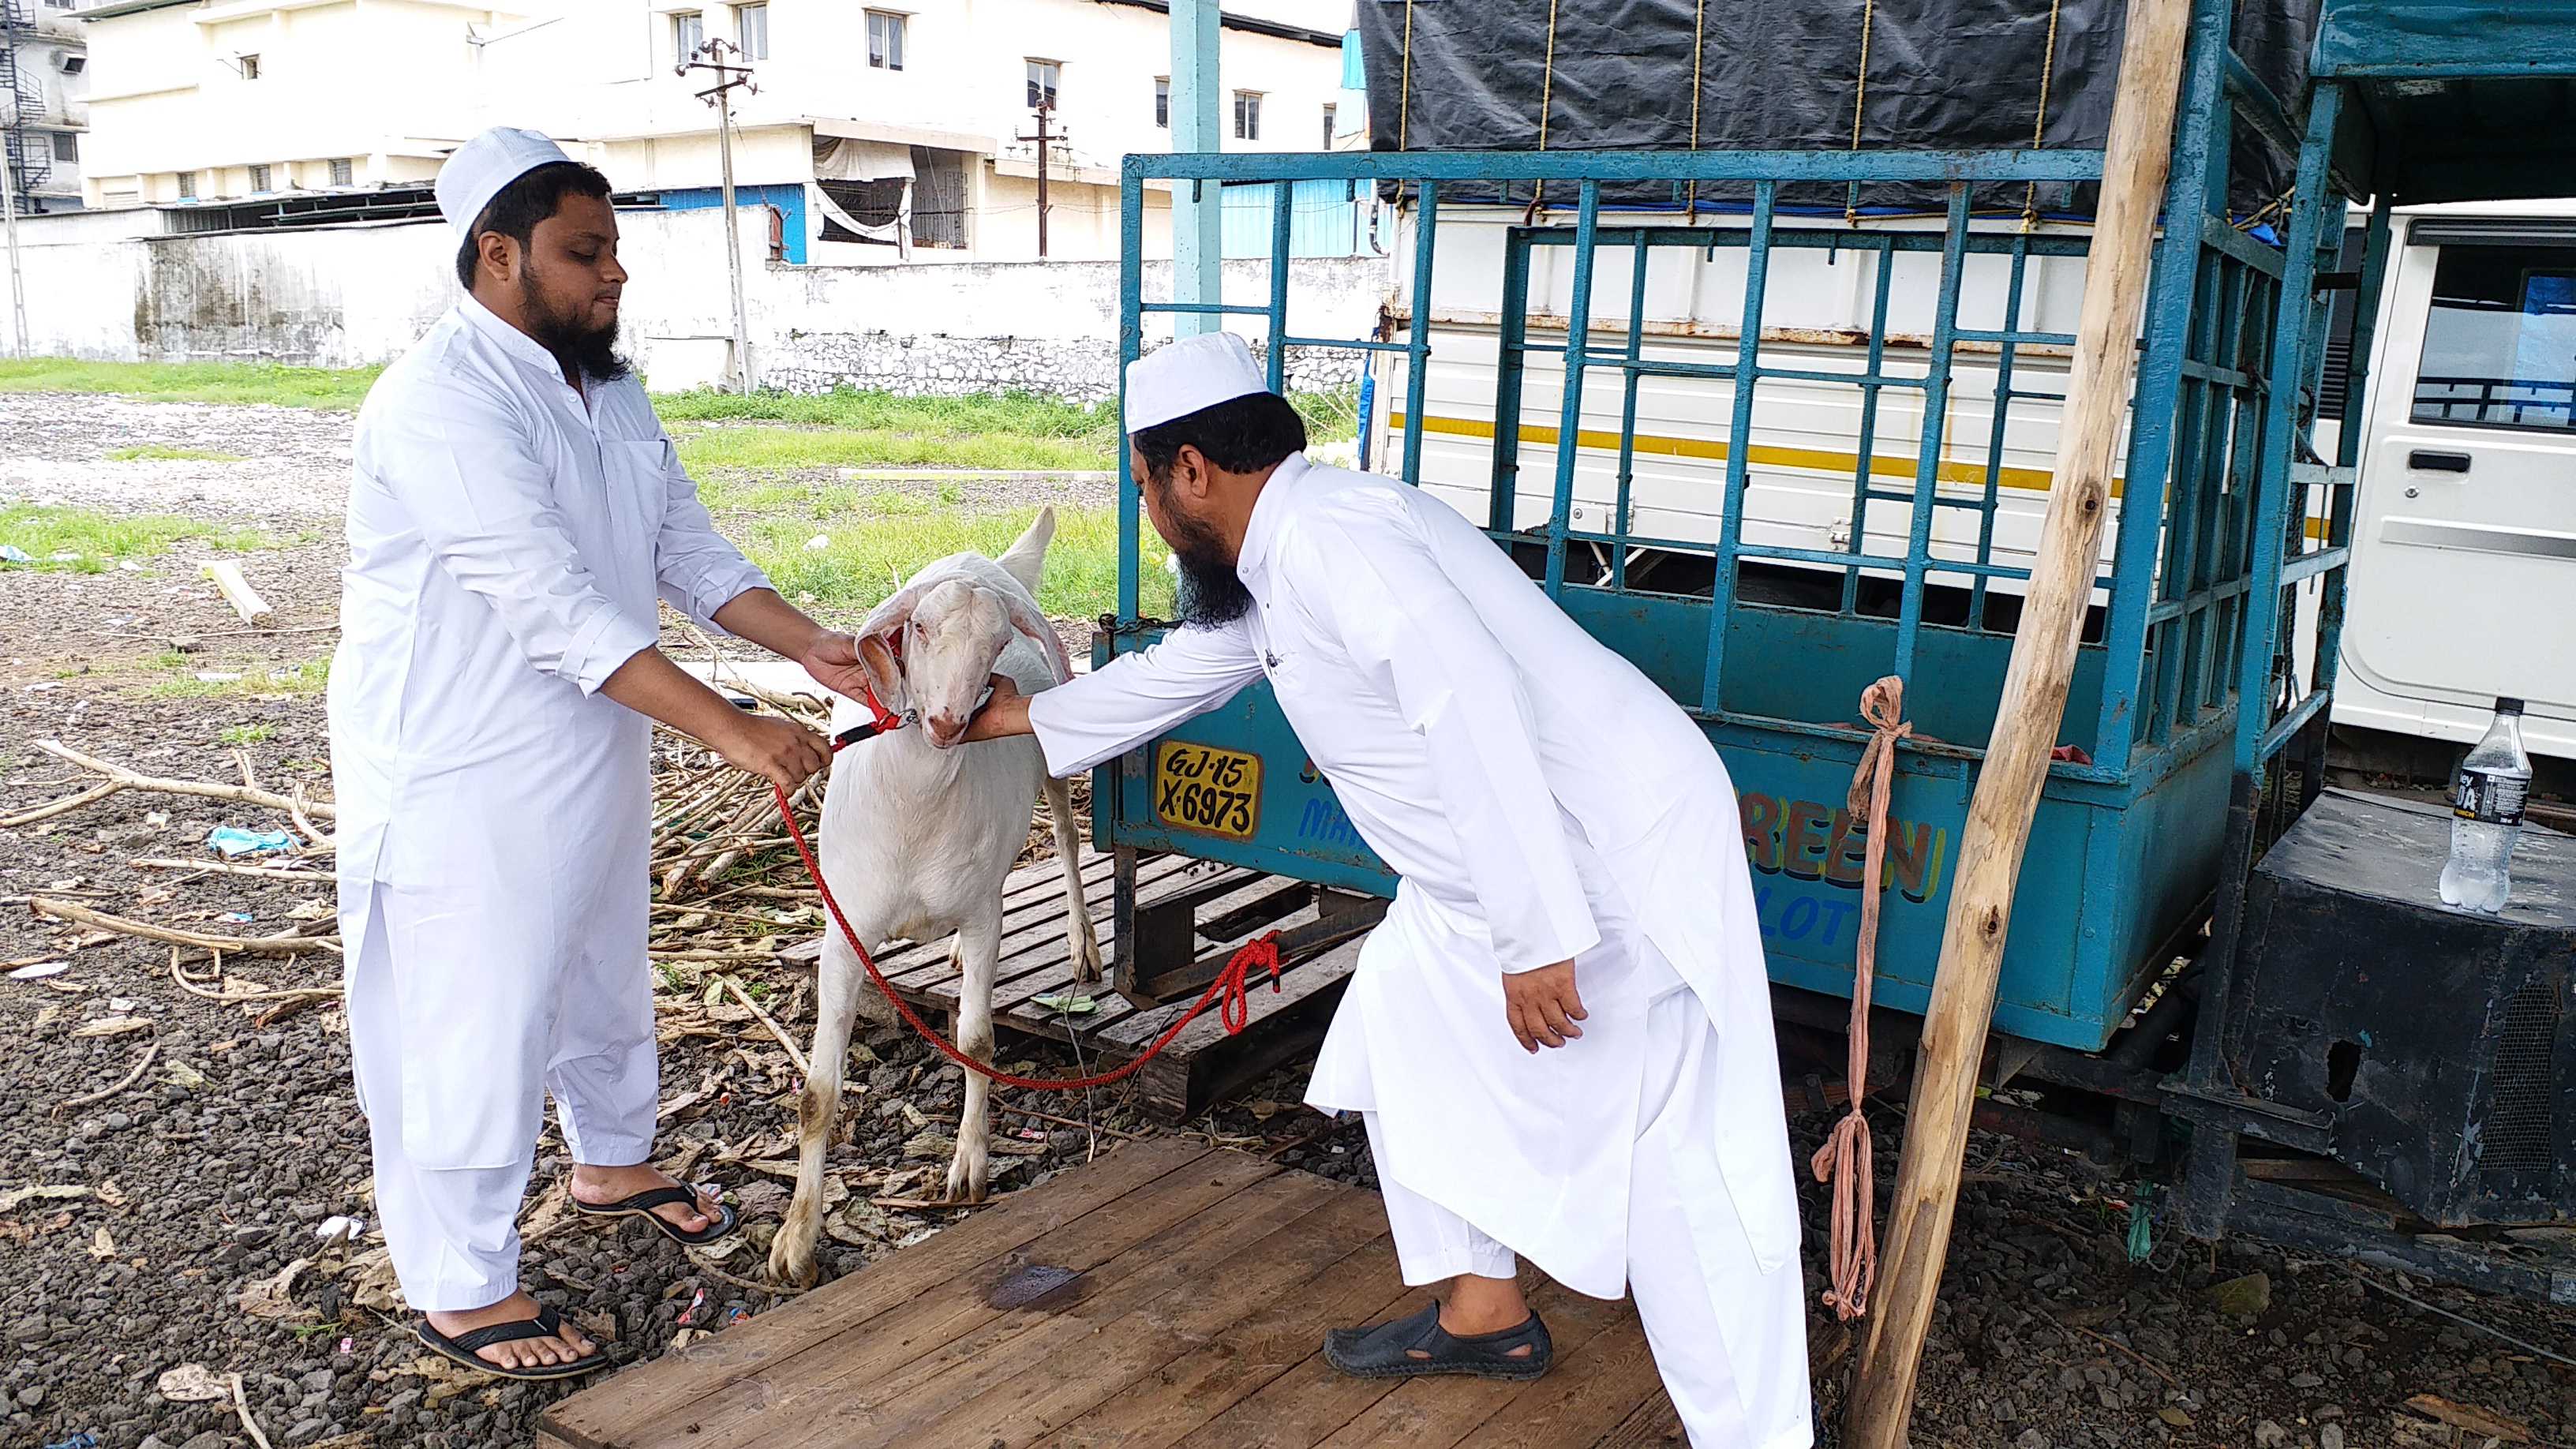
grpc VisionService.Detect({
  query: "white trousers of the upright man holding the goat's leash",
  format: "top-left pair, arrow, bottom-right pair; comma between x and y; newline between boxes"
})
348,882 -> 660,1312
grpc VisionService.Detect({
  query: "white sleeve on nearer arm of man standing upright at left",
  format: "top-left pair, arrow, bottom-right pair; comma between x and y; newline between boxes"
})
373,387 -> 660,694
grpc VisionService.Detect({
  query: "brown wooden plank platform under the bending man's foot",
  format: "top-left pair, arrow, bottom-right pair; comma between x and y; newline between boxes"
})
538,1140 -> 1682,1449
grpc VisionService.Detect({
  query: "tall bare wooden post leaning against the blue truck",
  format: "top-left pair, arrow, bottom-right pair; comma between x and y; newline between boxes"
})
1842,0 -> 2197,1449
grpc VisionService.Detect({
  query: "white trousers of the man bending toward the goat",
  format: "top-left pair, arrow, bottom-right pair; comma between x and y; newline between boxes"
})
1363,990 -> 1816,1449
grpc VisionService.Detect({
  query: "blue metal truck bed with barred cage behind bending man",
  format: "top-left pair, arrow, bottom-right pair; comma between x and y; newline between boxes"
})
1092,0 -> 2576,1289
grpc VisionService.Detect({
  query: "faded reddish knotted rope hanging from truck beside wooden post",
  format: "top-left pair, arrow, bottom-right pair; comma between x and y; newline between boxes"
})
1814,676 -> 1914,1323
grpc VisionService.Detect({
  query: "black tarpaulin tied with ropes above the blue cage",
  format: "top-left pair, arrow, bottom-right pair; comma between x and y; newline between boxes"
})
1357,0 -> 2316,214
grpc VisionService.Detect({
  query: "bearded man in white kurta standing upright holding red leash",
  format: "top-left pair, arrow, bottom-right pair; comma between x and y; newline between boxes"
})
330,132 -> 856,1377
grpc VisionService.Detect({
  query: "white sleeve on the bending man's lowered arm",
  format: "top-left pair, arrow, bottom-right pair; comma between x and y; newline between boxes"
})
1309,503 -> 1600,975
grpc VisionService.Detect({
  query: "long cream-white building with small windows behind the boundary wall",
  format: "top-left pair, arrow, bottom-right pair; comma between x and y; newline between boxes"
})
70,0 -> 1368,265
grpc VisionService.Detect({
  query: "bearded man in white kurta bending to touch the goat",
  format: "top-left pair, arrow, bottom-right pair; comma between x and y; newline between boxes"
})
972,335 -> 1811,1449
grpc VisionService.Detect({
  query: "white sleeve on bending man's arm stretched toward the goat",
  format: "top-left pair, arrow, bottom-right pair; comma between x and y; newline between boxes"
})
1028,624 -> 1262,779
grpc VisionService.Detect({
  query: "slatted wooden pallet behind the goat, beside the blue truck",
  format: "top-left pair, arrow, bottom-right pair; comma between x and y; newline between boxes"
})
781,851 -> 1360,1121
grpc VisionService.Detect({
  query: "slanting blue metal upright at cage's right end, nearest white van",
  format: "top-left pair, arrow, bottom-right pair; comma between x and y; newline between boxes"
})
2236,85 -> 2344,786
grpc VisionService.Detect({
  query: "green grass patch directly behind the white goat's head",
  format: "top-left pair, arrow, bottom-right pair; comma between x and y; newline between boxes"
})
726,492 -> 1172,619
